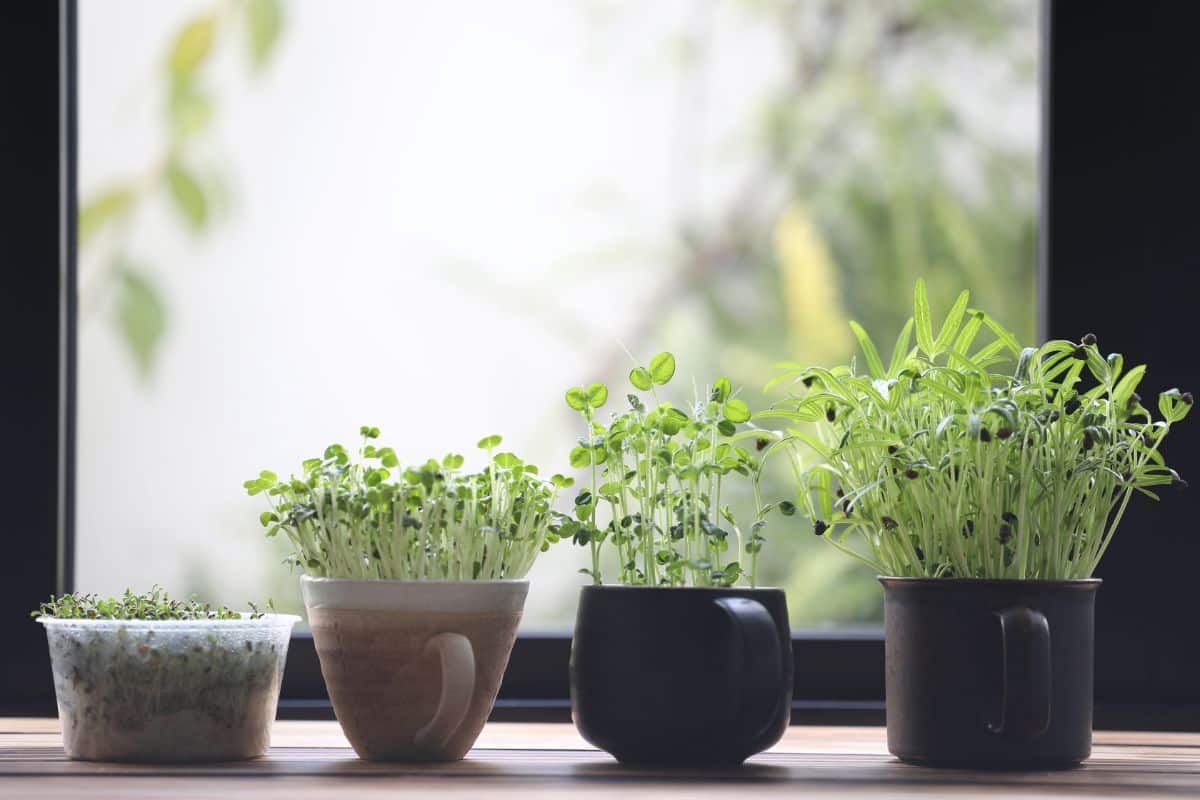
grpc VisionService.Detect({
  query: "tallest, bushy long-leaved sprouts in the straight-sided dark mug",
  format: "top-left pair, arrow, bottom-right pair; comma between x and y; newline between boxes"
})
761,282 -> 1193,579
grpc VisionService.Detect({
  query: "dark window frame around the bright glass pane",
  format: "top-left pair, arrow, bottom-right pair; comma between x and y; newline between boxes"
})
9,0 -> 1200,729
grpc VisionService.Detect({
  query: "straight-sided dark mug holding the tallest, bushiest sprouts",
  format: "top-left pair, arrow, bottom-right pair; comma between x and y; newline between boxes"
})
880,578 -> 1100,768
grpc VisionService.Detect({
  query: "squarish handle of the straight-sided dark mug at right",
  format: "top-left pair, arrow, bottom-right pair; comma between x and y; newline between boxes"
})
988,607 -> 1051,739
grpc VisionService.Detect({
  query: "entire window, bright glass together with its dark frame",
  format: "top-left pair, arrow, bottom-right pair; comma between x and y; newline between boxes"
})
11,2 -> 1200,724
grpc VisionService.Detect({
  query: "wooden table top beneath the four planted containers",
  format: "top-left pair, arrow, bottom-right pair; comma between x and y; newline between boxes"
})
0,717 -> 1200,800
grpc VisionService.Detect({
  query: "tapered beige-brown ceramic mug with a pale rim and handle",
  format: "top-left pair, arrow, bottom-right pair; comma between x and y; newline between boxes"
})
300,576 -> 529,762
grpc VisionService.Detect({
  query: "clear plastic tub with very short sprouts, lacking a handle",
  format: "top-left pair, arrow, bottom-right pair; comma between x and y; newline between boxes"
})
37,614 -> 300,762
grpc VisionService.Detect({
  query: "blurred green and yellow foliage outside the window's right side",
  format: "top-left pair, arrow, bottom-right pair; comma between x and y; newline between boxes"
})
573,0 -> 1038,626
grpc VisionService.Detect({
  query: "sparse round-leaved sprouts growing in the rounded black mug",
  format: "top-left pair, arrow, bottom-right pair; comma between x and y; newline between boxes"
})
562,353 -> 796,587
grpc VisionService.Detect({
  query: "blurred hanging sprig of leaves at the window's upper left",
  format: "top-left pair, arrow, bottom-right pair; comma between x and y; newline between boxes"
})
78,0 -> 283,380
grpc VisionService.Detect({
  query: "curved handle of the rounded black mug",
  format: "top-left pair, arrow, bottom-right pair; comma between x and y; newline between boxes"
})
713,597 -> 784,736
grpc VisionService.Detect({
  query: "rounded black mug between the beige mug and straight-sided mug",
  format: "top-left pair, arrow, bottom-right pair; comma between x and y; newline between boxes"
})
571,587 -> 792,765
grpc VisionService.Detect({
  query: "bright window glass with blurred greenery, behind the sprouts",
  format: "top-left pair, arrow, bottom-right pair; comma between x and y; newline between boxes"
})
77,0 -> 1038,630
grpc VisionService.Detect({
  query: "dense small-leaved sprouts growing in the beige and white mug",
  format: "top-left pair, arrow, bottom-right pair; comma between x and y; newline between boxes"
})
245,426 -> 574,581
